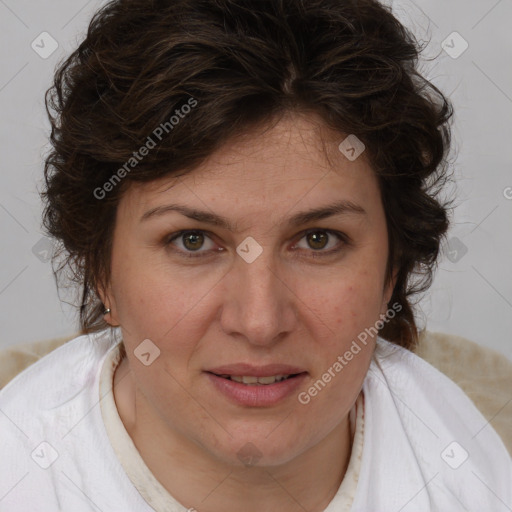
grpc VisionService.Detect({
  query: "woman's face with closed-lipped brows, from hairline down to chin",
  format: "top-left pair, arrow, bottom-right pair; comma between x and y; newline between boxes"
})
103,111 -> 392,465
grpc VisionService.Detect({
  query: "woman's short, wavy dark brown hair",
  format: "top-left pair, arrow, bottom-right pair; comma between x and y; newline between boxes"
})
41,0 -> 453,349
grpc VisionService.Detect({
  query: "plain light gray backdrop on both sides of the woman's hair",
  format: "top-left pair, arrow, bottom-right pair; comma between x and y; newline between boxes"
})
0,0 -> 512,359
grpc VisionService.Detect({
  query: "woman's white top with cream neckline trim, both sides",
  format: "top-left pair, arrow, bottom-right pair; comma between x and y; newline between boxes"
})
0,330 -> 512,512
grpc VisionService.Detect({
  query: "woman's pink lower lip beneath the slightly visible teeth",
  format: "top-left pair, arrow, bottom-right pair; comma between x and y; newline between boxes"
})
207,372 -> 307,407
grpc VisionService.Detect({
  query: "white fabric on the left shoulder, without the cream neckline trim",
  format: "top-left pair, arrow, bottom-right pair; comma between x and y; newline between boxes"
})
0,329 -> 149,512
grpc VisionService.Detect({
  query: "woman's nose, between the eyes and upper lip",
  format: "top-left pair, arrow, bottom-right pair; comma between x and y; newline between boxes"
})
221,250 -> 297,346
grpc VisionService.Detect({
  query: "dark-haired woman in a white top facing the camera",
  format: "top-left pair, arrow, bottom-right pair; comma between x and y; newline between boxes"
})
0,0 -> 512,512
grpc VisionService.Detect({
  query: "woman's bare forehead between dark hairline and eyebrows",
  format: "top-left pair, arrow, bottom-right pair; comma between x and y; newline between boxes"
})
120,114 -> 378,220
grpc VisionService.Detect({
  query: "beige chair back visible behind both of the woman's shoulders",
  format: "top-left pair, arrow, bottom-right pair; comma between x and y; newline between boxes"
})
0,331 -> 512,455
